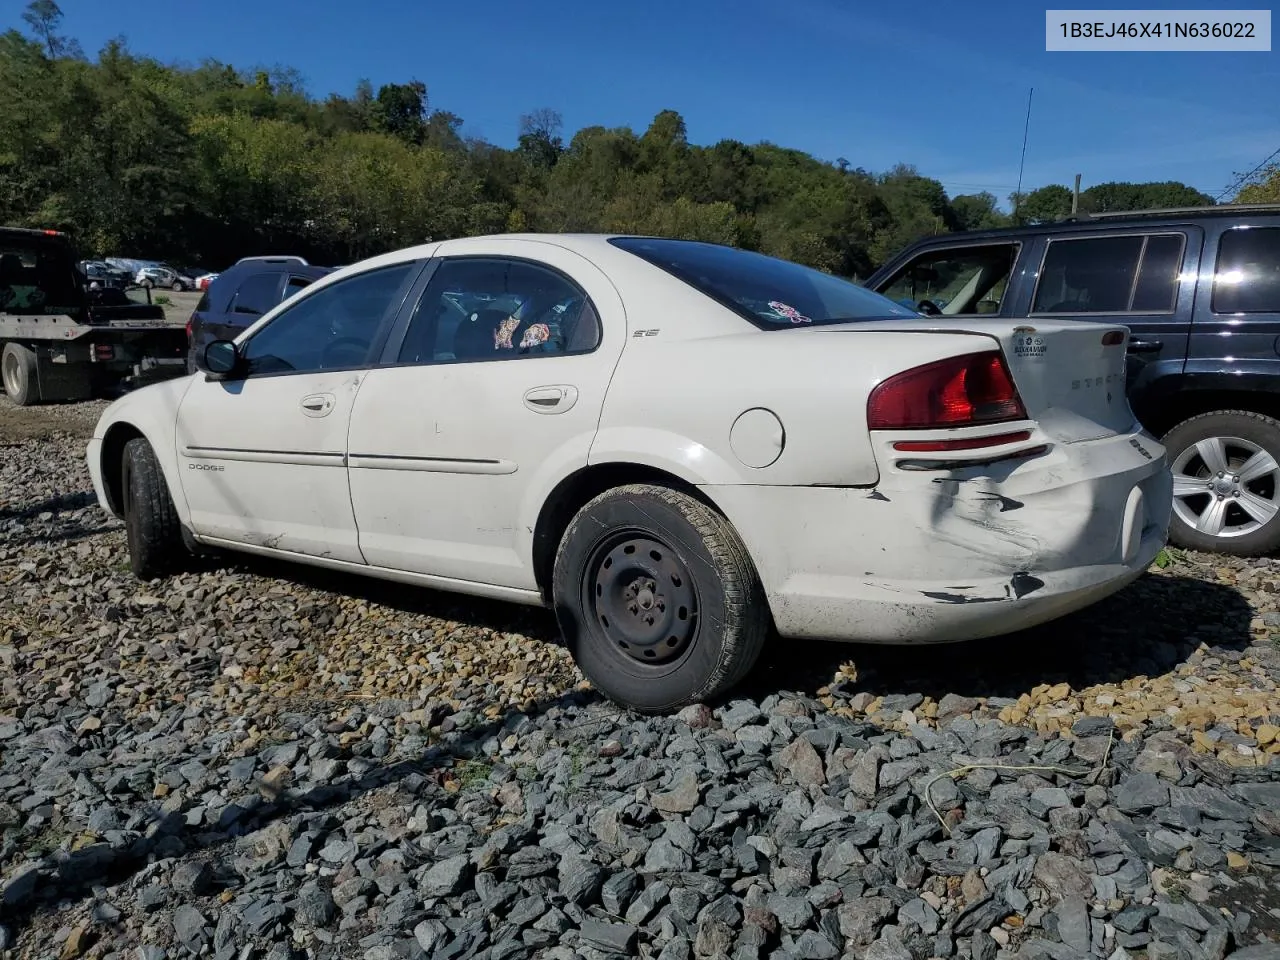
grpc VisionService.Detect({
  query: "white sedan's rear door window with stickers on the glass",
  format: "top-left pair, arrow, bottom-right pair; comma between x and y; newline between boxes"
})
397,257 -> 600,364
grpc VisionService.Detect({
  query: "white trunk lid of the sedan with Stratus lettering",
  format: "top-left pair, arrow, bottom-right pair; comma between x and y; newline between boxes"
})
813,317 -> 1135,443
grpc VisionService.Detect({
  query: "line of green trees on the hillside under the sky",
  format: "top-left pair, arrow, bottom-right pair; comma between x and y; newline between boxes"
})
0,0 -> 1213,278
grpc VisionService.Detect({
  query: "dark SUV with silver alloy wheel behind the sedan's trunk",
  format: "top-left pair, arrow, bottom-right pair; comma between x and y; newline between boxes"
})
867,205 -> 1280,557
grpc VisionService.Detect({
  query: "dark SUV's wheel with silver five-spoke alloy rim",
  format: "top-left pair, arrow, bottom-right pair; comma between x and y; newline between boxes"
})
1161,410 -> 1280,557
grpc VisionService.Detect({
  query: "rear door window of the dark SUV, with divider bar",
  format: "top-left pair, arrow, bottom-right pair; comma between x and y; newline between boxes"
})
1032,233 -> 1185,314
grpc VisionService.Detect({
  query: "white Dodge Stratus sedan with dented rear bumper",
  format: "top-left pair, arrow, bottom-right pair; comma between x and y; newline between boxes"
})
87,234 -> 1172,710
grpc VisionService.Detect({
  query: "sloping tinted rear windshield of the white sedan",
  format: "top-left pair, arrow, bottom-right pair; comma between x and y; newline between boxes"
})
609,237 -> 920,329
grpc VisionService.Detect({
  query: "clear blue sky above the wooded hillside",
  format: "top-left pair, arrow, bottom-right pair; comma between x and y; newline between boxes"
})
17,0 -> 1280,201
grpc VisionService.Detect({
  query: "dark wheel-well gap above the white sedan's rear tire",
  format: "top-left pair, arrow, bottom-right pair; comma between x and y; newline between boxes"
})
532,461 -> 728,603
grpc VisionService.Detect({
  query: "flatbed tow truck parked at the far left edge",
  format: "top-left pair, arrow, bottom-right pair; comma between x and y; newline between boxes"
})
0,227 -> 187,407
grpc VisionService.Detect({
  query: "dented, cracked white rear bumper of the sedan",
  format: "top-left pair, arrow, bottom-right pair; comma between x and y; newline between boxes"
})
705,433 -> 1172,644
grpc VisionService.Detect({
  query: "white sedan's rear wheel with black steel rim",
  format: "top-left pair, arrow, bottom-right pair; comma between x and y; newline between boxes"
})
552,484 -> 772,713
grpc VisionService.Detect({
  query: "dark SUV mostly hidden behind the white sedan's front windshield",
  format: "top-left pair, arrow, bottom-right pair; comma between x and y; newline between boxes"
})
187,256 -> 335,372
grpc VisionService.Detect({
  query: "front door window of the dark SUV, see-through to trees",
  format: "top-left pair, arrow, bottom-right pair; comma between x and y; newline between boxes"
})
881,243 -> 1018,316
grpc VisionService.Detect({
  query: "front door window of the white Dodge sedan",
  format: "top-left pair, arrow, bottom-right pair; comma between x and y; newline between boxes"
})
242,261 -> 420,376
